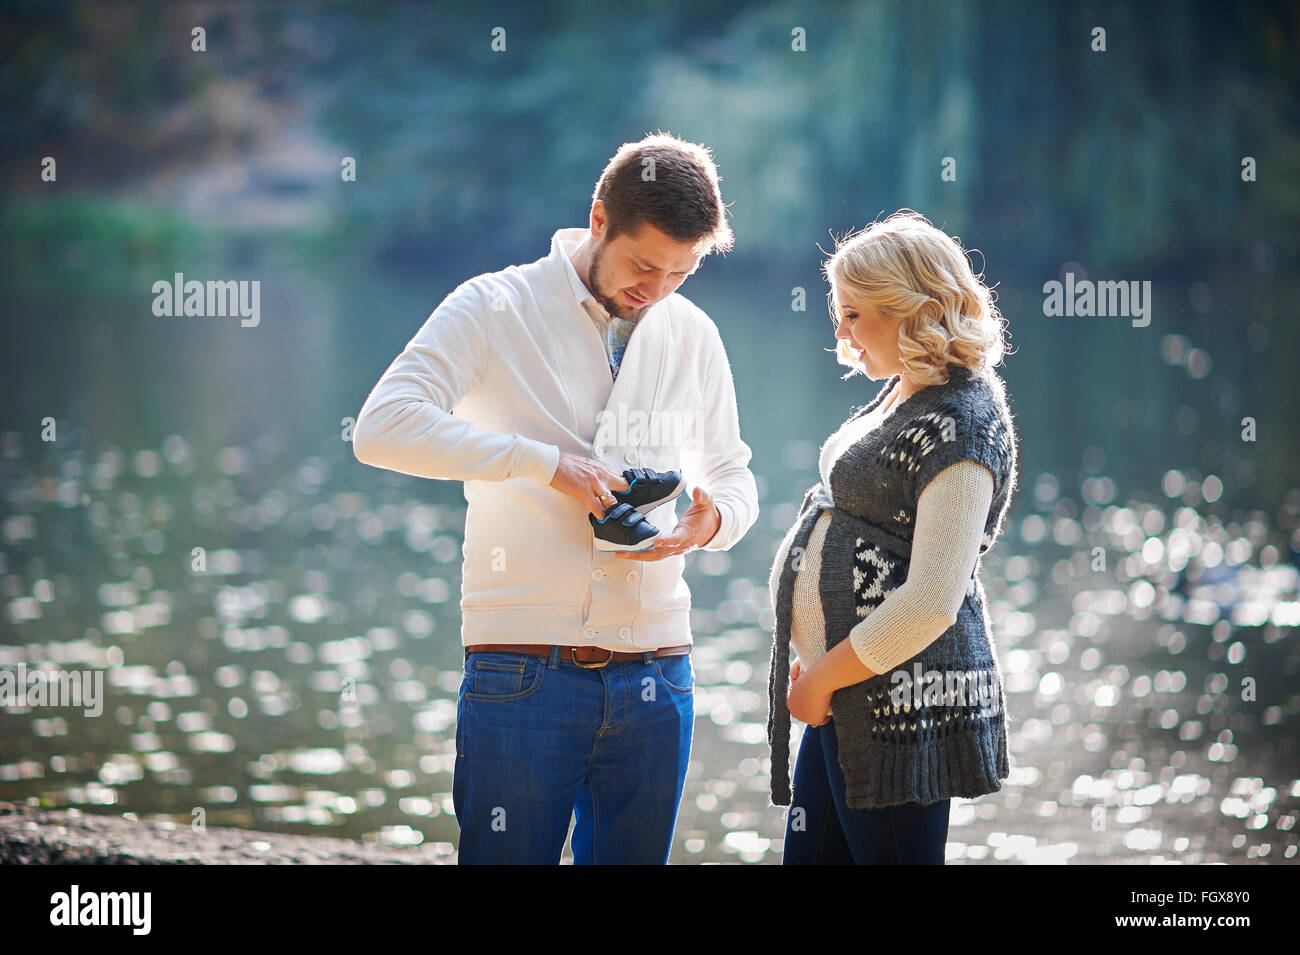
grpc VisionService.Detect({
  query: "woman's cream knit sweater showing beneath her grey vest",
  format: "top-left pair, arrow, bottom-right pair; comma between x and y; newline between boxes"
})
768,391 -> 993,673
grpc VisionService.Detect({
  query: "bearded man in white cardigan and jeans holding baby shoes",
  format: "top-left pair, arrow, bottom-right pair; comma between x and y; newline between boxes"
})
352,134 -> 758,864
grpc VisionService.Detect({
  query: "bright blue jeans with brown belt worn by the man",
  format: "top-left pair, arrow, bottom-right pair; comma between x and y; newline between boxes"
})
451,647 -> 696,865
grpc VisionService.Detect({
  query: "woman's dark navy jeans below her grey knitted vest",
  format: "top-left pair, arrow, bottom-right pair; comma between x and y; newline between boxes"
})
781,717 -> 952,865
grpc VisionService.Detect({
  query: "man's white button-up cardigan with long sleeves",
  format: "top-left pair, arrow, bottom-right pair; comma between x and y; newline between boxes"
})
352,229 -> 758,650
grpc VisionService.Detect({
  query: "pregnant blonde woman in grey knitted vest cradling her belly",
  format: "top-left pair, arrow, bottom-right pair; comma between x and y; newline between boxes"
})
768,210 -> 1017,864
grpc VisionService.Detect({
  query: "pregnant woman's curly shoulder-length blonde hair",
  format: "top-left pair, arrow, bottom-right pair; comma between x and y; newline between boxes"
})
822,209 -> 1006,385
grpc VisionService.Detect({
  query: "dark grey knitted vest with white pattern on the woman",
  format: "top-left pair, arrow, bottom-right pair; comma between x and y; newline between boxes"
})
767,363 -> 1017,809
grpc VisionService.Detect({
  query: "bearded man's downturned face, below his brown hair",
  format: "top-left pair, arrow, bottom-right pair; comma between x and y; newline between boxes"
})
586,222 -> 703,321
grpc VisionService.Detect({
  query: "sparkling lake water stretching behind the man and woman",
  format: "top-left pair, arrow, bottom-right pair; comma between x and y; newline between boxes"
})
0,236 -> 1300,863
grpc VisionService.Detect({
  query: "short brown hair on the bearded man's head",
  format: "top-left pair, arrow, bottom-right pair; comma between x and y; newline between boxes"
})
592,133 -> 735,255
